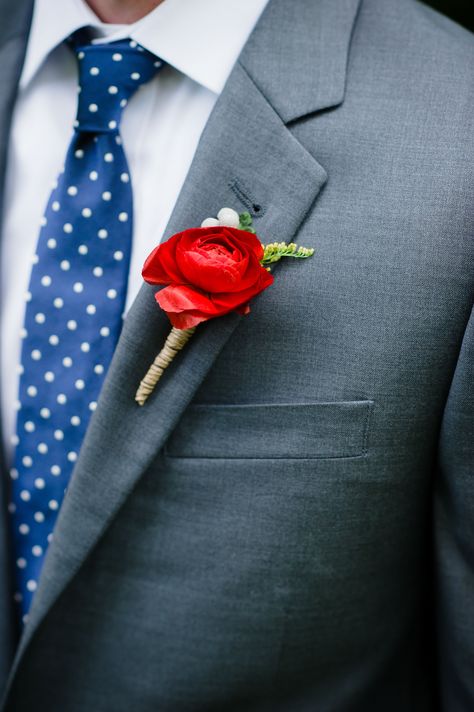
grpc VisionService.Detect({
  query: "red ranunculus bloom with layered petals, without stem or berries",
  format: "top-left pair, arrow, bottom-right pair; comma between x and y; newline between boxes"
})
142,226 -> 273,329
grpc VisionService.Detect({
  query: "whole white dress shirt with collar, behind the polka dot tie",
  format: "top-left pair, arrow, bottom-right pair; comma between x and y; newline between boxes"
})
0,0 -> 267,452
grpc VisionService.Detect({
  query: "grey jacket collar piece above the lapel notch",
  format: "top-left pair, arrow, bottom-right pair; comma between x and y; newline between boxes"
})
240,0 -> 361,123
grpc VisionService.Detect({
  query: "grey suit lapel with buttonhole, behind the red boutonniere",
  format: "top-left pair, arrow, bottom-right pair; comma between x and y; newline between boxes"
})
7,0 -> 358,675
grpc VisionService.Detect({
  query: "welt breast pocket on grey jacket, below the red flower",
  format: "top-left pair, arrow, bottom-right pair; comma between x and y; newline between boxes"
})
165,400 -> 374,460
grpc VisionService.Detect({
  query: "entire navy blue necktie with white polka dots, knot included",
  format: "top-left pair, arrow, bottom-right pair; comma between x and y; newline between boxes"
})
10,37 -> 162,621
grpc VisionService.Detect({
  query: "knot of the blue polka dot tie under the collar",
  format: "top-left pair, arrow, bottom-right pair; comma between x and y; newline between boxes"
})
72,38 -> 163,133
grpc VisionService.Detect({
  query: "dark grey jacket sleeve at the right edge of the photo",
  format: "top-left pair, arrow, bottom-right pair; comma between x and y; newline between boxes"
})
433,304 -> 474,712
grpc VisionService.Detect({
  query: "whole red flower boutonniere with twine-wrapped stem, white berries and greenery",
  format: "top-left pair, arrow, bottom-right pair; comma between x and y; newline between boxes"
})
135,208 -> 314,405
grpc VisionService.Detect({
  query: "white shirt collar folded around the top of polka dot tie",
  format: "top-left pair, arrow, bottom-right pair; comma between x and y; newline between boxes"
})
20,0 -> 268,94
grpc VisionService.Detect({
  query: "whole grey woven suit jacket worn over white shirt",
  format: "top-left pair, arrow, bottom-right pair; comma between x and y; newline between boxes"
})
0,0 -> 474,712
